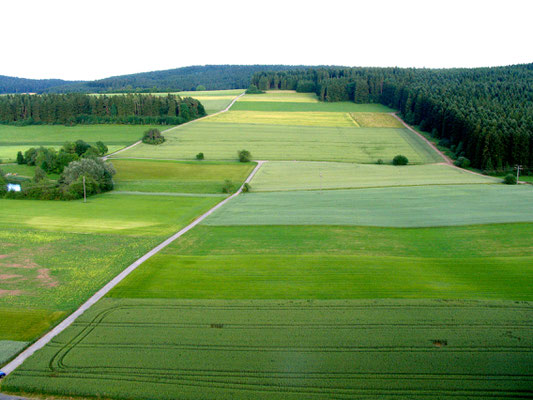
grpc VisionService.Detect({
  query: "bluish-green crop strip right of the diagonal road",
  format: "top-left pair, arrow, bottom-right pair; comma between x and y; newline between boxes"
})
202,185 -> 533,227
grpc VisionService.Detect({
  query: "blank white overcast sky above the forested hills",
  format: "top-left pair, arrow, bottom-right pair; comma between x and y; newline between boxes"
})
0,0 -> 533,80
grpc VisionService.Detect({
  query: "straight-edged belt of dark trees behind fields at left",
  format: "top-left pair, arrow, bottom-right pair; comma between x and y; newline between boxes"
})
0,93 -> 205,125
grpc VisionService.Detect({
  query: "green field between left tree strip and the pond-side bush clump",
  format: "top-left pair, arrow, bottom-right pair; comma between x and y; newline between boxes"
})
0,125 -> 156,162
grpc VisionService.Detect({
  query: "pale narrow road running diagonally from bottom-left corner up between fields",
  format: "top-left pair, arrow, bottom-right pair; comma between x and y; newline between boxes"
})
2,161 -> 264,375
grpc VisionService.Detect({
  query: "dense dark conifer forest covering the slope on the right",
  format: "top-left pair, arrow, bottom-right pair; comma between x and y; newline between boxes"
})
251,64 -> 533,171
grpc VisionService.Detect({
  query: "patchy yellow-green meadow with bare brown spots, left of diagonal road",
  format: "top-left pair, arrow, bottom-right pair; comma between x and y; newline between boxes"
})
0,194 -> 220,341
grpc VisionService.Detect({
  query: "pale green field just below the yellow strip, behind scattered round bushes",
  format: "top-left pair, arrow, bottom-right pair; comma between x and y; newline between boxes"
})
120,119 -> 443,164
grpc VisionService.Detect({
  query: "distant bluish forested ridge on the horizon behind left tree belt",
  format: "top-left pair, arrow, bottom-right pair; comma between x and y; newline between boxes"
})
0,65 -> 310,93
